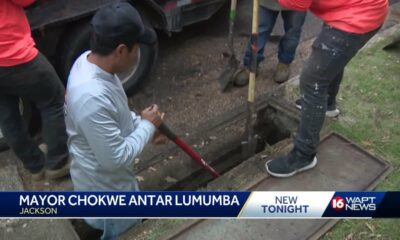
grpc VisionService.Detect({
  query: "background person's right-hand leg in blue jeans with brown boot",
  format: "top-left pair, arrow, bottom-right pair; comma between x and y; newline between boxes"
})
274,11 -> 307,83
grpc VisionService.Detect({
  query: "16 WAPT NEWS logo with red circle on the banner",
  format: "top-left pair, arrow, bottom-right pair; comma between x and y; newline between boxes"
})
331,196 -> 376,212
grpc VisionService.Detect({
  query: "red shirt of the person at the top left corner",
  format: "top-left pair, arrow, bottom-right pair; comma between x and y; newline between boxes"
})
0,0 -> 38,67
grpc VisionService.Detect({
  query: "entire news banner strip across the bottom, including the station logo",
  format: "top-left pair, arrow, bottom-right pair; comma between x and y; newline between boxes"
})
0,191 -> 400,219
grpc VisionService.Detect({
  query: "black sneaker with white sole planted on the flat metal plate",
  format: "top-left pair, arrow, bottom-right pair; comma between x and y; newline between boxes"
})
265,150 -> 317,178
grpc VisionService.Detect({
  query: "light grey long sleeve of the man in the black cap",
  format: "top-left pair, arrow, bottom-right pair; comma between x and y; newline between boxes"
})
78,96 -> 156,170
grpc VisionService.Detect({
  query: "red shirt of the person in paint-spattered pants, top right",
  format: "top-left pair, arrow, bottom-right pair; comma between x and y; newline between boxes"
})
278,0 -> 389,34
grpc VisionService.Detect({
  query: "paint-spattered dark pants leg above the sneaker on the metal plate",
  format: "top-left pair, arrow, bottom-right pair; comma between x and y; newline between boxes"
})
294,25 -> 378,156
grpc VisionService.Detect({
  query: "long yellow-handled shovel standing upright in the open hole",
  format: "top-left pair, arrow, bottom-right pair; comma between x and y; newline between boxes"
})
242,0 -> 260,159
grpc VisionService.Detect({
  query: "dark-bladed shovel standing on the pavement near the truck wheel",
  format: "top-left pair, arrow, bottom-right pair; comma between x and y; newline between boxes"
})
219,0 -> 240,92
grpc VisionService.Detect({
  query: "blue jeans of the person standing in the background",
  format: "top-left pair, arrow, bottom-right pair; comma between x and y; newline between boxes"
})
243,6 -> 307,68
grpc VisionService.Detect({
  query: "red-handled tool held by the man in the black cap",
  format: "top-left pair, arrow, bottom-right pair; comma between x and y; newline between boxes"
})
158,123 -> 220,178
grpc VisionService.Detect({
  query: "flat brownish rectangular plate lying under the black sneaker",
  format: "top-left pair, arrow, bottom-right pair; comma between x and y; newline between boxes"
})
165,134 -> 389,240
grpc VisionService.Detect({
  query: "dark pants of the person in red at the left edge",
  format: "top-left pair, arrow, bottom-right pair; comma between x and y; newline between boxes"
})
0,53 -> 68,172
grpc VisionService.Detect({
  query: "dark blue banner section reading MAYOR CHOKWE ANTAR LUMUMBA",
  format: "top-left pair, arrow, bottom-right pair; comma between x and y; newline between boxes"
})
0,192 -> 250,218
